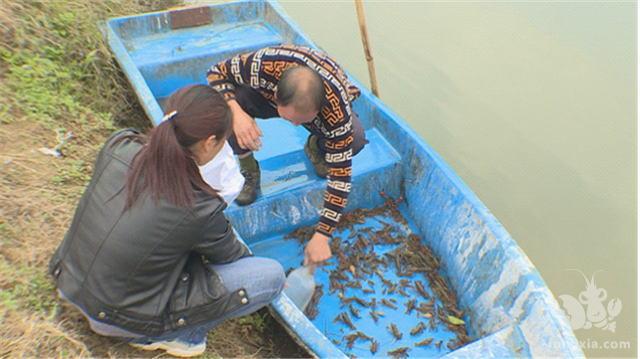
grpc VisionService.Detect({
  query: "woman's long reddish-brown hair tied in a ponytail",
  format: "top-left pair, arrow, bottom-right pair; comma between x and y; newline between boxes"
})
124,85 -> 231,211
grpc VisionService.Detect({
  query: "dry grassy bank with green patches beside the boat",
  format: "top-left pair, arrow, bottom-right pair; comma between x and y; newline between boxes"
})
0,0 -> 300,357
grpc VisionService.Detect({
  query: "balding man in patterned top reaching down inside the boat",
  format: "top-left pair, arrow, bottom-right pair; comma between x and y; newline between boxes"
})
207,45 -> 367,264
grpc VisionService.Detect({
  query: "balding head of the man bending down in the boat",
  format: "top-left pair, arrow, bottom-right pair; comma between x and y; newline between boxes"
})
276,65 -> 324,112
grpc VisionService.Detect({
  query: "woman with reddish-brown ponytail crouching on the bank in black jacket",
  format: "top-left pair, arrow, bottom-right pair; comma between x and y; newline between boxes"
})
49,85 -> 284,356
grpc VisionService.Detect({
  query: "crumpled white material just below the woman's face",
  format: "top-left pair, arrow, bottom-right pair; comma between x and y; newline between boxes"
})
198,142 -> 244,204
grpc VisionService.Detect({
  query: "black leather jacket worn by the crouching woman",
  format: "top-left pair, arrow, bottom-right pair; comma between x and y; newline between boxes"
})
49,130 -> 250,336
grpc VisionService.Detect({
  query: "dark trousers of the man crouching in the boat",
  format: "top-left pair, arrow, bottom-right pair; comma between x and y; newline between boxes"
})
229,86 -> 369,156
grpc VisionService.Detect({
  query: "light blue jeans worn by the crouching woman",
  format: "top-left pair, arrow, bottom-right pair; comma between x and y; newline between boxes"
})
66,257 -> 285,344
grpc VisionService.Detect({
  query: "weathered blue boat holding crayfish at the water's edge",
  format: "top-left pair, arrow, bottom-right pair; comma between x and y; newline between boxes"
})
103,1 -> 584,358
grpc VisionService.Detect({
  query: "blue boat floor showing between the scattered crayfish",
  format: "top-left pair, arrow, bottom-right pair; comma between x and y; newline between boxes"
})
251,205 -> 462,358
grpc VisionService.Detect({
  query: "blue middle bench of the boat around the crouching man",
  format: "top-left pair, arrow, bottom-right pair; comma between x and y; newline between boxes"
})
226,118 -> 400,207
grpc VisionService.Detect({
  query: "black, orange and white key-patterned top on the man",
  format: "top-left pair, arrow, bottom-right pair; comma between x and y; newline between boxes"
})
207,45 -> 360,235
